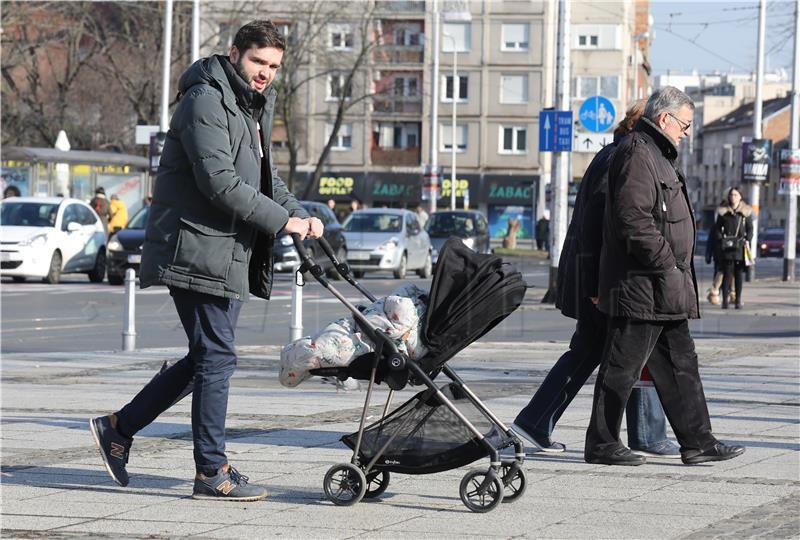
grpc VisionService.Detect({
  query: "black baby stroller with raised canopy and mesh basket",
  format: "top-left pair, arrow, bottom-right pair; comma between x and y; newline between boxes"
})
294,235 -> 526,512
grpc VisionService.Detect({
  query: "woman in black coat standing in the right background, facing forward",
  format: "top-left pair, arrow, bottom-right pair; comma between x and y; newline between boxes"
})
714,187 -> 753,309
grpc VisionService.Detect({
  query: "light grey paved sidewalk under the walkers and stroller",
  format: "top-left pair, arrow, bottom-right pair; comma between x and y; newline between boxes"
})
0,284 -> 800,539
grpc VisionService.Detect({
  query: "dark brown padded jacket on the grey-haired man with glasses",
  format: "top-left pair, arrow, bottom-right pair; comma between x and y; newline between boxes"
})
598,118 -> 700,321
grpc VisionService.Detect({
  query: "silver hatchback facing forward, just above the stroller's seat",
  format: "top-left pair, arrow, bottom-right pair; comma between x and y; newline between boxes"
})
342,208 -> 433,279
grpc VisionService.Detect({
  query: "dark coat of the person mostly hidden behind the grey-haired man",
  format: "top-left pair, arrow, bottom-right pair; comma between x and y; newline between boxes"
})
556,137 -> 618,319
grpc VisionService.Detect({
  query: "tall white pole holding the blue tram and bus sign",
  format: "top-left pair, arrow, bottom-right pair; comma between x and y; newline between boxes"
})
542,0 -> 572,302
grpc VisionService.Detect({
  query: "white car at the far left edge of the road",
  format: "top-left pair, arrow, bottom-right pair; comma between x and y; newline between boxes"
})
0,197 -> 106,283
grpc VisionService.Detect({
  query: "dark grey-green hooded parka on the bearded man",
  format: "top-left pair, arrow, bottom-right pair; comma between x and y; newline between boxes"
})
140,56 -> 308,300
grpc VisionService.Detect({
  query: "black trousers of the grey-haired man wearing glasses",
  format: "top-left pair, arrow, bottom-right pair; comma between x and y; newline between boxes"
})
585,318 -> 717,455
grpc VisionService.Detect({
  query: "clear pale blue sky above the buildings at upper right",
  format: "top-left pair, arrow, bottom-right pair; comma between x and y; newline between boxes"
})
650,0 -> 795,76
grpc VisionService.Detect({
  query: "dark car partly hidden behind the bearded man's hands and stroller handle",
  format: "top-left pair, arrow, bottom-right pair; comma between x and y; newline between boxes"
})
273,201 -> 347,279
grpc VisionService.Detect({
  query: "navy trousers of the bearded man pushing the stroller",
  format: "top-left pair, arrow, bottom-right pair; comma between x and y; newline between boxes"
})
116,288 -> 242,476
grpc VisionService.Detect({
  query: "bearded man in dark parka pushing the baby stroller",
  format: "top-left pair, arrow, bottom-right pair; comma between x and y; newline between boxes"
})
89,20 -> 323,501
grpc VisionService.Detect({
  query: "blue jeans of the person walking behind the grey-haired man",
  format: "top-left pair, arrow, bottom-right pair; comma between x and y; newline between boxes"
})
515,305 -> 667,448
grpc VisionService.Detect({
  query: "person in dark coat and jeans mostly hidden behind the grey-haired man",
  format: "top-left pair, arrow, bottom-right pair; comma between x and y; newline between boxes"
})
513,100 -> 681,458
